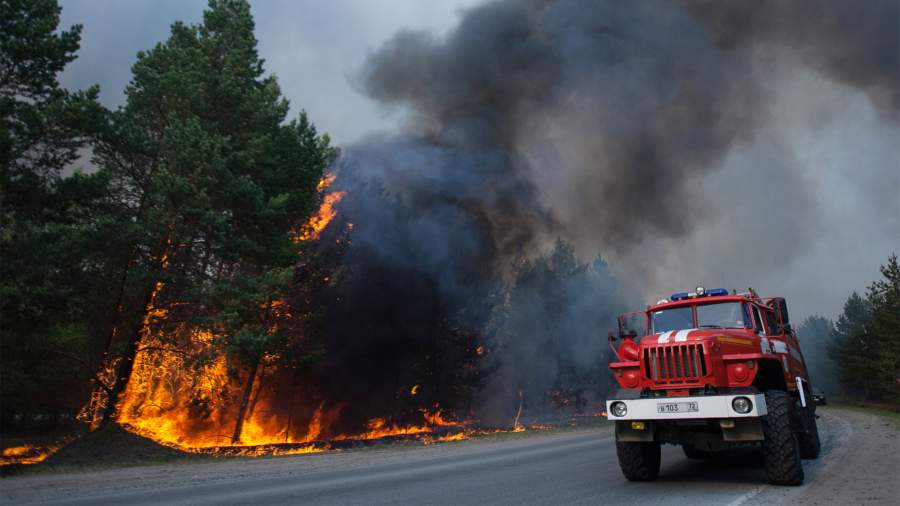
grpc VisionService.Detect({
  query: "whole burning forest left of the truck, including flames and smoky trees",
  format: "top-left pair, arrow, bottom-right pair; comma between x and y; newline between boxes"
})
0,0 -> 621,446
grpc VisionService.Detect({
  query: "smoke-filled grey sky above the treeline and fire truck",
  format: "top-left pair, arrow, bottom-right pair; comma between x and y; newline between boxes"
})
344,0 -> 900,316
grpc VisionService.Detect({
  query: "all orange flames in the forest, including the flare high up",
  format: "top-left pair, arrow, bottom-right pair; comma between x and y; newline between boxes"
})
93,174 -> 486,455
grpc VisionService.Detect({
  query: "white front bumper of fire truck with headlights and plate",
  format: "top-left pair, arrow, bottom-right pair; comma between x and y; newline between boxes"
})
606,394 -> 768,420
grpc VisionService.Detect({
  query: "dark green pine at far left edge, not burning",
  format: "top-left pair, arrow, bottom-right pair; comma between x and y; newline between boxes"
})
0,0 -> 109,426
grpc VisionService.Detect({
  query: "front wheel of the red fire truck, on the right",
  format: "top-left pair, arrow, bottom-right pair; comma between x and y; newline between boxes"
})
762,390 -> 803,485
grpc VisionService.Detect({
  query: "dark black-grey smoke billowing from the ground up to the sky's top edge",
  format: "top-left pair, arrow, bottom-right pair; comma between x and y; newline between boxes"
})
298,0 -> 900,426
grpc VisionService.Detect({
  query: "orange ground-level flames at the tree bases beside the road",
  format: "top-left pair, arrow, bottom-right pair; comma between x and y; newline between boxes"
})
112,324 -> 472,455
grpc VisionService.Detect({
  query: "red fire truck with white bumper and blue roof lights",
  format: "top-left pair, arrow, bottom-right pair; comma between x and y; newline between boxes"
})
606,287 -> 820,485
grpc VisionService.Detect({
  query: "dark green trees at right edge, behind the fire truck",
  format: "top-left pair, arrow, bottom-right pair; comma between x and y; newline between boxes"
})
798,254 -> 900,406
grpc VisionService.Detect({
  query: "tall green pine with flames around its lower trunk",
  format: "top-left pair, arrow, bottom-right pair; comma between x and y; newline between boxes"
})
89,0 -> 334,434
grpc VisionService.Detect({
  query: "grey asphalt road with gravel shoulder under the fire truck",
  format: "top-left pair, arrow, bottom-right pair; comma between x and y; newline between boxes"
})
0,408 -> 900,506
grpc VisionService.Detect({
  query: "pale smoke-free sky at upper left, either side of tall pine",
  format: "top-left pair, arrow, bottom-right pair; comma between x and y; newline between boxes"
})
61,0 -> 480,144
